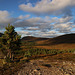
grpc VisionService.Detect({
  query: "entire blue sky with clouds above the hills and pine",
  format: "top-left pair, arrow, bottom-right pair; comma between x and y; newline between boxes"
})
0,0 -> 75,38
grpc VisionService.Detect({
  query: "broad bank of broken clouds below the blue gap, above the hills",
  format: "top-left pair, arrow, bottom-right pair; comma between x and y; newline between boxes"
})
0,11 -> 75,37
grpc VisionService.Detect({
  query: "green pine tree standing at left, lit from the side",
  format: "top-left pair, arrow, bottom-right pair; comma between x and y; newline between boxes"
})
1,24 -> 21,60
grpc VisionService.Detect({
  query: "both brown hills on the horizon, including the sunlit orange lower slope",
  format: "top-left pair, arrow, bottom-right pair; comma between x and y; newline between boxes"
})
22,34 -> 75,49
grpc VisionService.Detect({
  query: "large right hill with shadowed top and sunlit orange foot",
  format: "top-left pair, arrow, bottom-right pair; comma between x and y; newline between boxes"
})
36,34 -> 75,49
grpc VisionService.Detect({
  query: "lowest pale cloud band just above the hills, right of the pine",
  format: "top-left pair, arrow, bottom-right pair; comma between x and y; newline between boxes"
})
18,30 -> 59,38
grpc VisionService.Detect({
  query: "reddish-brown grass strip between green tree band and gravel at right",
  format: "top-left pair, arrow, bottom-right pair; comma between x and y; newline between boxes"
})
44,53 -> 75,62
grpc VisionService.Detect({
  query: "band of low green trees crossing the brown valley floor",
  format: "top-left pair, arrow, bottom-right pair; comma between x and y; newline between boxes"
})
24,49 -> 75,57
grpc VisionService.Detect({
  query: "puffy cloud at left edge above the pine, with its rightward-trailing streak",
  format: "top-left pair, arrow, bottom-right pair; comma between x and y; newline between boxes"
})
0,10 -> 30,29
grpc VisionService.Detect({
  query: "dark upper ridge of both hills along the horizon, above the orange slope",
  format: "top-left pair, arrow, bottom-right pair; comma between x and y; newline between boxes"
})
22,33 -> 75,45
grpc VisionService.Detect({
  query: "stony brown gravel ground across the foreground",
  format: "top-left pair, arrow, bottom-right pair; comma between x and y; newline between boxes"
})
15,59 -> 75,75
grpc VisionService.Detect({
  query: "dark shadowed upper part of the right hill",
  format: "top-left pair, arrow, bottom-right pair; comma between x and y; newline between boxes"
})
47,34 -> 75,45
